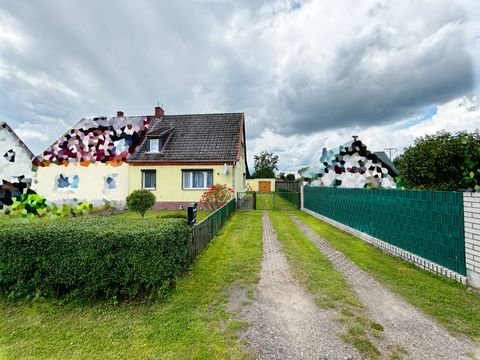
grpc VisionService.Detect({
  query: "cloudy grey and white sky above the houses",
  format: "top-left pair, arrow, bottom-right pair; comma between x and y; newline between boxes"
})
0,0 -> 480,171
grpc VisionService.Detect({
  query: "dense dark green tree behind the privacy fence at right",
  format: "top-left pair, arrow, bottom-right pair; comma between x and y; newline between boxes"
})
394,130 -> 480,191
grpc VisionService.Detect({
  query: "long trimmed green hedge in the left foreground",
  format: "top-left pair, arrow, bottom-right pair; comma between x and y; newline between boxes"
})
0,216 -> 191,299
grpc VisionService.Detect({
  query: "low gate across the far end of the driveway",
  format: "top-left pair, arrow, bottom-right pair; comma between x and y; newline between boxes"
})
237,191 -> 299,210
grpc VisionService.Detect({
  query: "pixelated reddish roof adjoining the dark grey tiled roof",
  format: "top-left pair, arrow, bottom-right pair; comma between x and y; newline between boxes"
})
33,116 -> 153,166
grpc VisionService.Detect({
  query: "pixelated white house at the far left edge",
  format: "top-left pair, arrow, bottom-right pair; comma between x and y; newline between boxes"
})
0,122 -> 34,208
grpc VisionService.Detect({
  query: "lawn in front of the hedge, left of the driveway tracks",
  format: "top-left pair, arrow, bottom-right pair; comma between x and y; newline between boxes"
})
0,211 -> 262,359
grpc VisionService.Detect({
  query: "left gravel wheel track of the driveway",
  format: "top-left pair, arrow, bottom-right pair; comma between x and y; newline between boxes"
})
241,213 -> 360,359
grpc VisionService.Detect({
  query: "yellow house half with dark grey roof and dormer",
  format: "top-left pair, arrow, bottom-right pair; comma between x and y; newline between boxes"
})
128,113 -> 248,209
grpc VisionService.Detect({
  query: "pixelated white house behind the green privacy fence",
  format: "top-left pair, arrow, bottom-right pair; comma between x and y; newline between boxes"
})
300,136 -> 398,189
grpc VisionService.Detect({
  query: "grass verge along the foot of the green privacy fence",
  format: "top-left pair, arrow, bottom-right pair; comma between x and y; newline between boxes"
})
295,211 -> 480,343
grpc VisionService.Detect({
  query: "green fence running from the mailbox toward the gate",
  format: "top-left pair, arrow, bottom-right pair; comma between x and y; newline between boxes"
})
191,199 -> 236,260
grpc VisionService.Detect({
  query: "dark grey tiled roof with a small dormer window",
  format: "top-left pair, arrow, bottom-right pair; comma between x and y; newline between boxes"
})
129,113 -> 243,162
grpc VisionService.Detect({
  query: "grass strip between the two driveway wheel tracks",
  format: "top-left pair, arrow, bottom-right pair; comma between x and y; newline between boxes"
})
269,211 -> 383,359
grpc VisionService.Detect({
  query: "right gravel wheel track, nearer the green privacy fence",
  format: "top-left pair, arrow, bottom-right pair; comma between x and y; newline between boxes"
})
291,215 -> 480,359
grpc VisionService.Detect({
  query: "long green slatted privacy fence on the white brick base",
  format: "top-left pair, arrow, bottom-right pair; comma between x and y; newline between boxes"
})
304,186 -> 466,275
